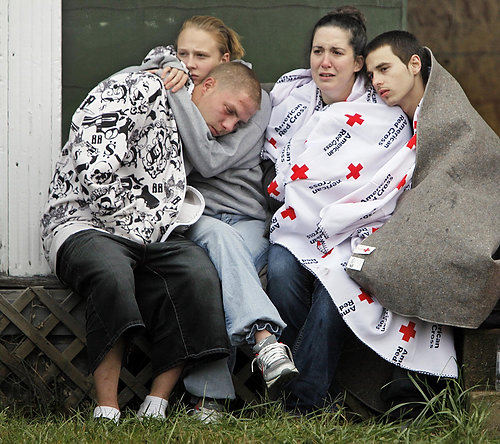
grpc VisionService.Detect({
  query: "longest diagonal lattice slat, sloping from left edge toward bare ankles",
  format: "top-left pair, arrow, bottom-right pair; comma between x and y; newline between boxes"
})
0,295 -> 89,391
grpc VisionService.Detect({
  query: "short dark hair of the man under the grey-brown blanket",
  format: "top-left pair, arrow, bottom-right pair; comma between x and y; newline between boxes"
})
364,30 -> 431,84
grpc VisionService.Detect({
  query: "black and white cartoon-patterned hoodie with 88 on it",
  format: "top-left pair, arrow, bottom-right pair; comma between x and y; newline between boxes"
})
41,72 -> 204,270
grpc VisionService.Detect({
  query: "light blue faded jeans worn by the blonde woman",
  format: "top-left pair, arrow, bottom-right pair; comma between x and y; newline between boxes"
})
184,213 -> 286,399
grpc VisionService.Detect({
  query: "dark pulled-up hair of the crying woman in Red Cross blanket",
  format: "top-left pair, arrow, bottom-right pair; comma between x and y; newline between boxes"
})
309,6 -> 366,57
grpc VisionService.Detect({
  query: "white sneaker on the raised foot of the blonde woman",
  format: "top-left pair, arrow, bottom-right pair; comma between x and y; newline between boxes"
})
252,335 -> 299,399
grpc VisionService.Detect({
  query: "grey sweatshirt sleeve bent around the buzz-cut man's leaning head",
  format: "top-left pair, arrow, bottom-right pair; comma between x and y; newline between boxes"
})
168,88 -> 271,177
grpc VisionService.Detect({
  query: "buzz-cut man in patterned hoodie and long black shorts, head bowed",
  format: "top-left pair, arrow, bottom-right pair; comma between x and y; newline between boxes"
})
41,63 -> 261,422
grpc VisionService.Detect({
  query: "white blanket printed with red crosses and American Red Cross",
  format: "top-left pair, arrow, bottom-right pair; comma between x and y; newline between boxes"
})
263,70 -> 457,377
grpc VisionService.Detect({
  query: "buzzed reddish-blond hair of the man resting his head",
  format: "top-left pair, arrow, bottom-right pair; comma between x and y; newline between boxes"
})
208,62 -> 262,108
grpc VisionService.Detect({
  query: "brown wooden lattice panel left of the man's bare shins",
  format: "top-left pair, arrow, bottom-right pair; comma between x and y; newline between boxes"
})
0,287 -> 92,407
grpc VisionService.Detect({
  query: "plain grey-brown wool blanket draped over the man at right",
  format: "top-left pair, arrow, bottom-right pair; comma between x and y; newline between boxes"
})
347,51 -> 500,328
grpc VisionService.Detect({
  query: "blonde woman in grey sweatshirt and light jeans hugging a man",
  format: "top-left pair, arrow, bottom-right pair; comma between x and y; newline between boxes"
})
121,16 -> 297,421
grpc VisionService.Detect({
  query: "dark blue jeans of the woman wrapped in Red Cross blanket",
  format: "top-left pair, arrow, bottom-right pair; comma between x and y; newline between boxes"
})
267,244 -> 348,412
